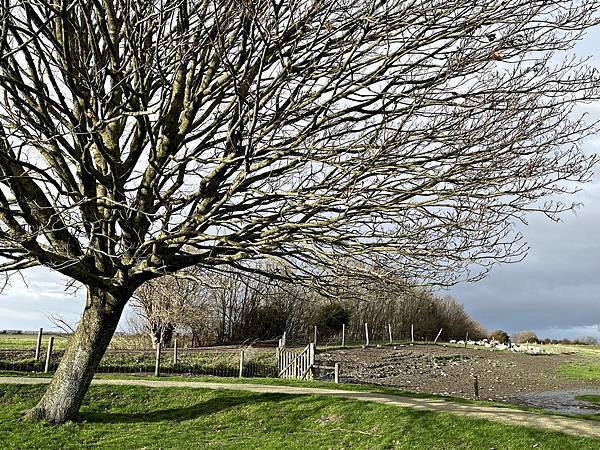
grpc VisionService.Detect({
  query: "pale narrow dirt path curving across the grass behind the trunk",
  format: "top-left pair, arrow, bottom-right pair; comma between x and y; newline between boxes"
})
0,377 -> 600,438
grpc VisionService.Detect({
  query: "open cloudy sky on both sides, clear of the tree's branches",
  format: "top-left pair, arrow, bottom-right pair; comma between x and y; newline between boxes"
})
0,31 -> 600,338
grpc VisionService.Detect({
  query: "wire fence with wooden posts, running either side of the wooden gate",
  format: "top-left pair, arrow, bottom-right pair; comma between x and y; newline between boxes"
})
0,324 -> 412,381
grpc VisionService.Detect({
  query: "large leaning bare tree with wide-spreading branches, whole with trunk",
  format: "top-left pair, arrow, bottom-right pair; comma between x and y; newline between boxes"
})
0,0 -> 600,422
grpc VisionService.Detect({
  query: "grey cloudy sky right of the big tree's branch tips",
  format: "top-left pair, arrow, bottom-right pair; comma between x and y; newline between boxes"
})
451,29 -> 600,339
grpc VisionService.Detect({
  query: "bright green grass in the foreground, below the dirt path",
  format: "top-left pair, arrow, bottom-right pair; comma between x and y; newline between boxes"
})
0,385 -> 600,449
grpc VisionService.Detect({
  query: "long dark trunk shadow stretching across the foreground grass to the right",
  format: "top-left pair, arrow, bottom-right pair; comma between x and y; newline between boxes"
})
79,394 -> 295,424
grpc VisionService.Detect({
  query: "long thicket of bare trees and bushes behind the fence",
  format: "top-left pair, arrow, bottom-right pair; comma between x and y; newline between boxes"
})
131,268 -> 486,346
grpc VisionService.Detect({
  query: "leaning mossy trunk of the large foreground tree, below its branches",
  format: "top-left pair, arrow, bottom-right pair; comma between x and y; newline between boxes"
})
25,287 -> 127,423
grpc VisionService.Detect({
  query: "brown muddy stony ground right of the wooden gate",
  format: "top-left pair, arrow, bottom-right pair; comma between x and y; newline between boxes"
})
318,345 -> 600,404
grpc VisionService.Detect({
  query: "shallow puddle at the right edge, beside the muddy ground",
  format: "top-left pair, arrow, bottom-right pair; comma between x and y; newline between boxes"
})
514,389 -> 600,414
